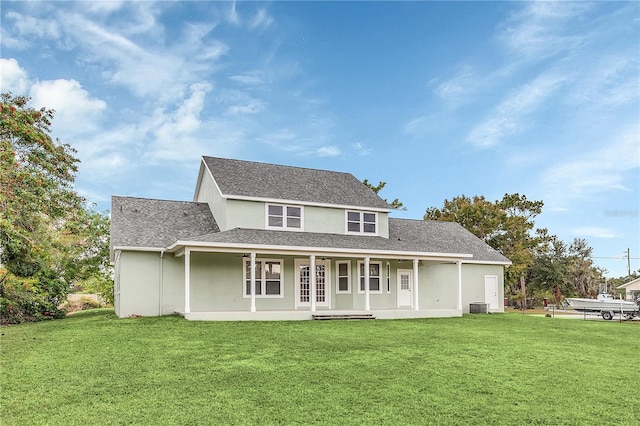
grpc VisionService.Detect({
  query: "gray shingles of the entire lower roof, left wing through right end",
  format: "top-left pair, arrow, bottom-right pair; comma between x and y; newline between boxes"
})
111,196 -> 509,262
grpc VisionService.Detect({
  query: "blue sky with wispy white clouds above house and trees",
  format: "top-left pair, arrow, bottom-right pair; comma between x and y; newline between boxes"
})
0,0 -> 640,277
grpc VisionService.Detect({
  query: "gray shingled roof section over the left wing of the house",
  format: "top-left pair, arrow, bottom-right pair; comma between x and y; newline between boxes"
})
111,196 -> 220,248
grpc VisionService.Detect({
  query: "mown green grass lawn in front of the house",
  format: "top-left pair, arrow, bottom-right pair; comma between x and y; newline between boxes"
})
0,309 -> 640,426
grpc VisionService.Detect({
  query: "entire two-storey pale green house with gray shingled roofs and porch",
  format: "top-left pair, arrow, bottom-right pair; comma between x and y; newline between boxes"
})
111,157 -> 510,320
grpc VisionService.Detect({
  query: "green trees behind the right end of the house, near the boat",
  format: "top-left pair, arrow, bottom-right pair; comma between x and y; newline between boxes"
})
424,193 -> 603,301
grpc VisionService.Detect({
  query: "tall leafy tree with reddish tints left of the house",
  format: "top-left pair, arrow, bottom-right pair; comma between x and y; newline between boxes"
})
0,93 -> 109,319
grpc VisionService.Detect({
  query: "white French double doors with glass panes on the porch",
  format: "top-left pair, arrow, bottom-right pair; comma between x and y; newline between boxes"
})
296,259 -> 331,308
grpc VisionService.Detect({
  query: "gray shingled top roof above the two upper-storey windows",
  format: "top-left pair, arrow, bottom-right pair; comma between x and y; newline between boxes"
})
203,157 -> 389,209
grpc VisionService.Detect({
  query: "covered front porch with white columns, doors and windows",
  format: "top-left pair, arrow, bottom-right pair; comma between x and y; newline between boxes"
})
168,244 -> 472,321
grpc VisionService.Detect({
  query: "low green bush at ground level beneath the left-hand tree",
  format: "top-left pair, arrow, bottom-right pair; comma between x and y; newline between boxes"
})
0,270 -> 67,325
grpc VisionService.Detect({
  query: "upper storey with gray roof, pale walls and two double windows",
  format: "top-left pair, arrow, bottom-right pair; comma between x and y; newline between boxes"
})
194,157 -> 389,238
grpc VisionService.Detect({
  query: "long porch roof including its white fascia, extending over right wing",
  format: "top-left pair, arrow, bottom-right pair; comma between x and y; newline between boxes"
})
168,219 -> 511,264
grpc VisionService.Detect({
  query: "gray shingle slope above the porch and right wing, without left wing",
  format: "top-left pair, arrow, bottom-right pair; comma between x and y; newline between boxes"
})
170,219 -> 509,262
